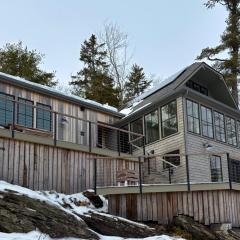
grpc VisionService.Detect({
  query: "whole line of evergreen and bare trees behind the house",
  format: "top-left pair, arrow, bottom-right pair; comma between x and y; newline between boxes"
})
0,0 -> 240,109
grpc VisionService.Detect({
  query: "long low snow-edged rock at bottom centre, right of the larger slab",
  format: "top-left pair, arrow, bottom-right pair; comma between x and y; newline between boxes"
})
81,212 -> 156,238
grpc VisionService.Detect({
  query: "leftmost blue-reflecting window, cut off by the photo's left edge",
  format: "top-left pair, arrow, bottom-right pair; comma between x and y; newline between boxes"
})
0,93 -> 14,126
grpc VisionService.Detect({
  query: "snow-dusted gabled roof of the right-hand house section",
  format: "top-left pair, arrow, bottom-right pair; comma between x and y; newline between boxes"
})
121,62 -> 238,121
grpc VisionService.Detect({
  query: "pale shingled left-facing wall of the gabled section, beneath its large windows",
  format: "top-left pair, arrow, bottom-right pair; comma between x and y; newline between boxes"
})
144,97 -> 186,183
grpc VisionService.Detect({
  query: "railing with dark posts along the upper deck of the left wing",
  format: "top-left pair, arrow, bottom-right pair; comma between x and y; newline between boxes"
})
0,95 -> 144,156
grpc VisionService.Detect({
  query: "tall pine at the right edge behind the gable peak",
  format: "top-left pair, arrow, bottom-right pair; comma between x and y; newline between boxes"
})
197,0 -> 240,103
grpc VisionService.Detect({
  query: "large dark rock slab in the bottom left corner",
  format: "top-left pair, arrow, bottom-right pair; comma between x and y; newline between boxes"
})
0,192 -> 99,239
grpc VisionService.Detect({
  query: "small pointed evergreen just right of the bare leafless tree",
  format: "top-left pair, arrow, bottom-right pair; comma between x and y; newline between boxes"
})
125,64 -> 152,102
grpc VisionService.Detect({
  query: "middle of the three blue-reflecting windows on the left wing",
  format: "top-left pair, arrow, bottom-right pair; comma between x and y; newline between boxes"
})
17,98 -> 33,128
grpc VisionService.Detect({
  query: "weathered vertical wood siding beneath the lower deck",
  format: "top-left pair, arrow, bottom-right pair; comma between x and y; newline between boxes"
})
108,190 -> 240,227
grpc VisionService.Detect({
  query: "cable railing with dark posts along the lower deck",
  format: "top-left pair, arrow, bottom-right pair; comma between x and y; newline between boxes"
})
94,152 -> 240,192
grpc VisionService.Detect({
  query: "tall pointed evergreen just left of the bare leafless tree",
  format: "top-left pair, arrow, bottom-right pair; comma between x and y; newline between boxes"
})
70,35 -> 118,107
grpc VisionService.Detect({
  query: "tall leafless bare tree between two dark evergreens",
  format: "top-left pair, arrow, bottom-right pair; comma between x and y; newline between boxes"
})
99,22 -> 131,107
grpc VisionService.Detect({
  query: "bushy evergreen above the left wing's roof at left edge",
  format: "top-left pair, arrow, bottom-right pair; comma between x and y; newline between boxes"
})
0,42 -> 57,86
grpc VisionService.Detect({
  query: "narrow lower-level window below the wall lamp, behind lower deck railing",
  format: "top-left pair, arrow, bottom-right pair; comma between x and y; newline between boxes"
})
210,156 -> 223,182
